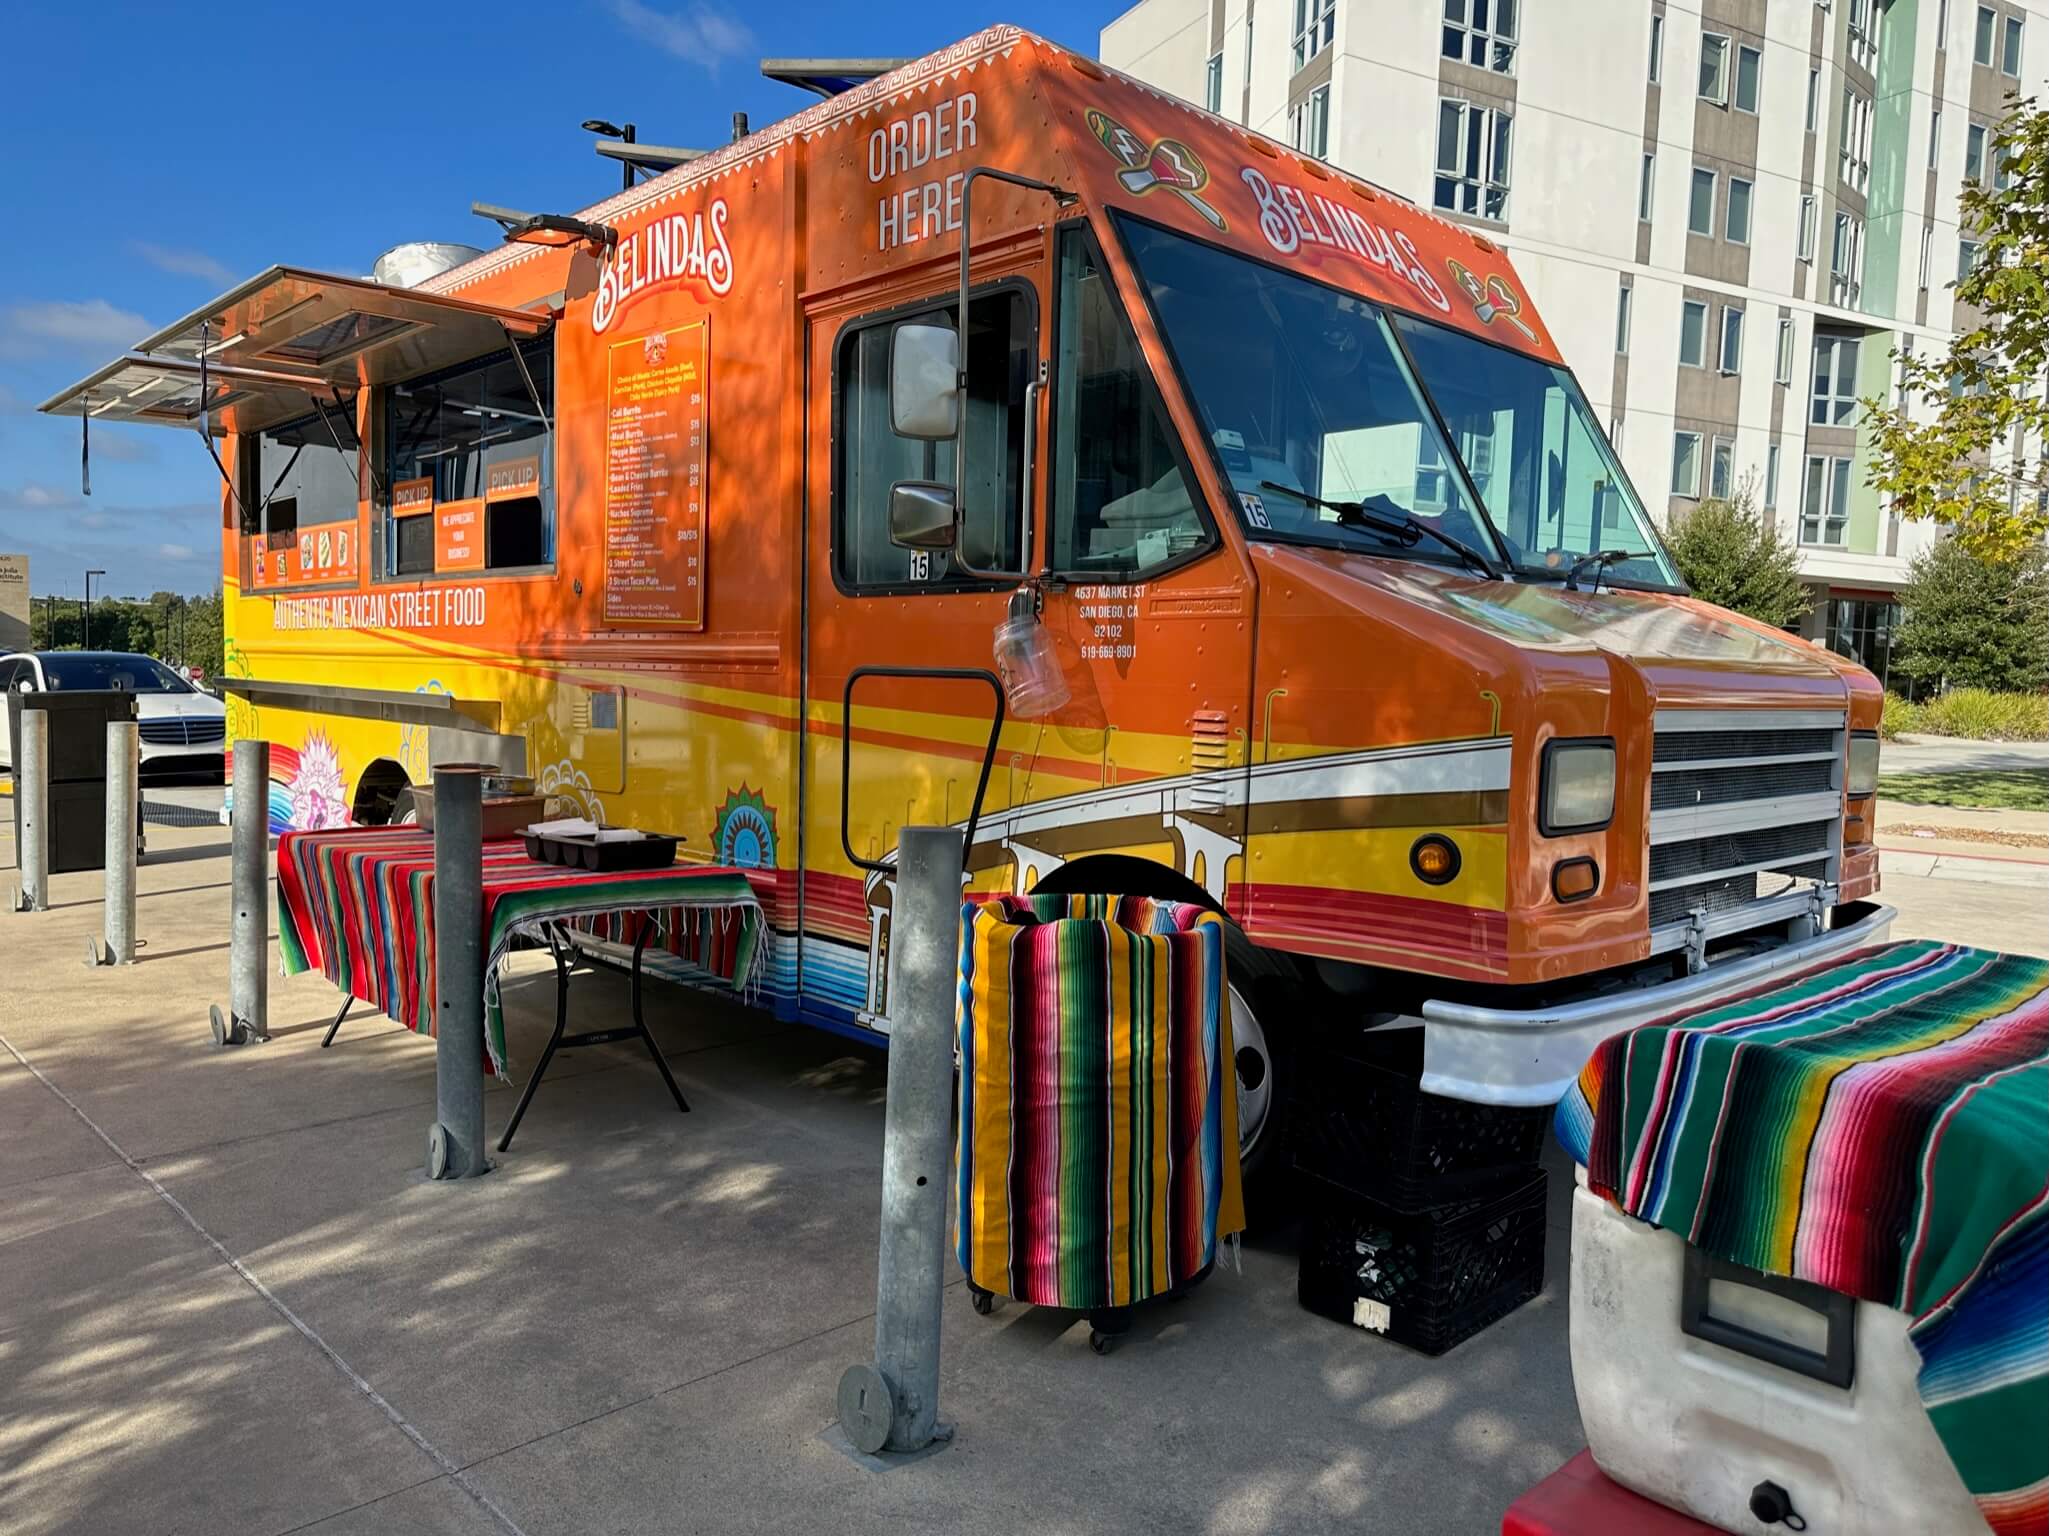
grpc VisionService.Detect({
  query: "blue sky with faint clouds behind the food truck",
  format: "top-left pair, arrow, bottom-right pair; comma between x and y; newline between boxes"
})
0,0 -> 1125,598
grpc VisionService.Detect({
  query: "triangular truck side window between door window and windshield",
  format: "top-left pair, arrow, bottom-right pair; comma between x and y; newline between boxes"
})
1047,225 -> 1209,578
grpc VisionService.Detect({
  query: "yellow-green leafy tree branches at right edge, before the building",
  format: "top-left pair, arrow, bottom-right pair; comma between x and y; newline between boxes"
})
1863,94 -> 2049,559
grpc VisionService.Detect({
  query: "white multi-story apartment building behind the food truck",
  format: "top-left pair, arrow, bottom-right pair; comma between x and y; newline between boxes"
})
1102,0 -> 2049,674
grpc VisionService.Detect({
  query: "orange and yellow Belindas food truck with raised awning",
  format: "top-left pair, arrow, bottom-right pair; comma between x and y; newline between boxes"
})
45,27 -> 1891,1163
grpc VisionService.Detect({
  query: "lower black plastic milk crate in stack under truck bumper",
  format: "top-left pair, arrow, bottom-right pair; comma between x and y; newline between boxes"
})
1295,1169 -> 1547,1354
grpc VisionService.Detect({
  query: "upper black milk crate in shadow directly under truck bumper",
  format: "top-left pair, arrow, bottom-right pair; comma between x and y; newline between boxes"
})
1293,1030 -> 1551,1208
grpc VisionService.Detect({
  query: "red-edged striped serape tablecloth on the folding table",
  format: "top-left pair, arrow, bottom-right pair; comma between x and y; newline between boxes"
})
277,827 -> 766,1077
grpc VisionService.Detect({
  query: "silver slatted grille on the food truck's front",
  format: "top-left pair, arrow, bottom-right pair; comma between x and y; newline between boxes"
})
1649,709 -> 1846,948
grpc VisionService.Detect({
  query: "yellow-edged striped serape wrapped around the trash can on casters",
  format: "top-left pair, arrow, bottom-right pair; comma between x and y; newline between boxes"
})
957,895 -> 1246,1343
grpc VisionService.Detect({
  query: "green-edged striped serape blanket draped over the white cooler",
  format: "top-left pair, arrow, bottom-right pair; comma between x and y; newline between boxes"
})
1557,940 -> 2049,1536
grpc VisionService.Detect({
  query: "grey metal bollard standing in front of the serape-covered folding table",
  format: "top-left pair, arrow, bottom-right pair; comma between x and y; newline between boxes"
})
426,768 -> 492,1180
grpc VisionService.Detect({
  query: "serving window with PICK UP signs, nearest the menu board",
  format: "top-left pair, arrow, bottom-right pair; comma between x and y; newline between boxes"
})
385,336 -> 555,575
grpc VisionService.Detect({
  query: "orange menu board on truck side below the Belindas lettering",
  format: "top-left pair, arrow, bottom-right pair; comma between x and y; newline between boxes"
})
604,319 -> 711,629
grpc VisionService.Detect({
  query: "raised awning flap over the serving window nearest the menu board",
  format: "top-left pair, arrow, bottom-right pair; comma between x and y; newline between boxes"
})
135,266 -> 553,387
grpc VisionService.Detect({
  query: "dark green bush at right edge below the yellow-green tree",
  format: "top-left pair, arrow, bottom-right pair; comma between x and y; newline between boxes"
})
1893,539 -> 2049,690
